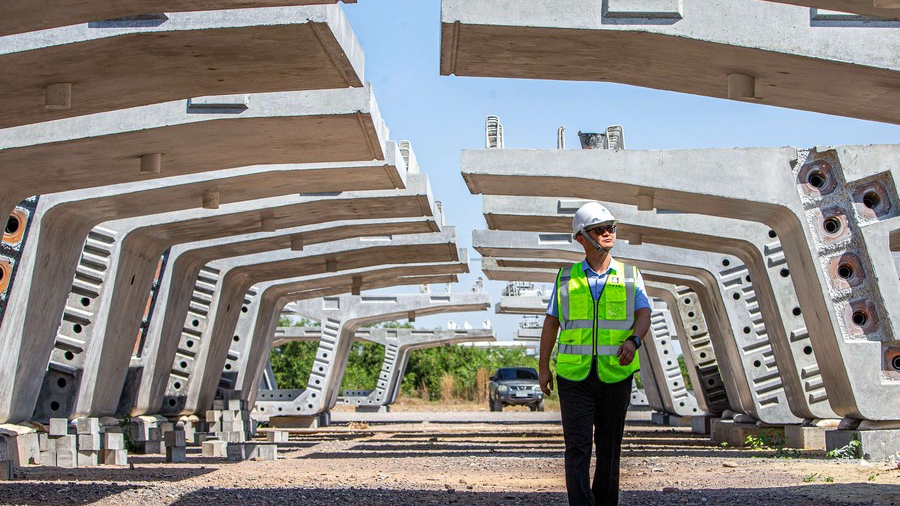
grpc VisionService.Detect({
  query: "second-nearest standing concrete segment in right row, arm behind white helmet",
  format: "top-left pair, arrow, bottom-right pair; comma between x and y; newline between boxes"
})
484,195 -> 837,419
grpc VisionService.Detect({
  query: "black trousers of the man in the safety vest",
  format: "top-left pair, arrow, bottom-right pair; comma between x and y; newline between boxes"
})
556,366 -> 632,506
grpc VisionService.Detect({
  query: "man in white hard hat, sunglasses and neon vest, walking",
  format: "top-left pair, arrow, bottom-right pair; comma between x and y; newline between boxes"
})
539,202 -> 650,506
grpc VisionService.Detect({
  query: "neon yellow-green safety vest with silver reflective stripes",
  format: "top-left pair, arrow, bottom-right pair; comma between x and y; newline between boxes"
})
556,259 -> 640,383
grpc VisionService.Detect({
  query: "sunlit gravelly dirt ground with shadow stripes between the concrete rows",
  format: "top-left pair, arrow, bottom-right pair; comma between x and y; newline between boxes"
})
0,406 -> 900,506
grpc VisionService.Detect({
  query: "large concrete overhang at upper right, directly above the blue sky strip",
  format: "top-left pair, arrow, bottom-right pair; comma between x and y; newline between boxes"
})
441,0 -> 900,123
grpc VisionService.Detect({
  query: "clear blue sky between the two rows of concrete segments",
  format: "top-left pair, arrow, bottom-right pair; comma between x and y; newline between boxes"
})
343,0 -> 900,339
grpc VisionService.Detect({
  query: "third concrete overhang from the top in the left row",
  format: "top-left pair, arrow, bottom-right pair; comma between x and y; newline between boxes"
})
0,87 -> 387,223
